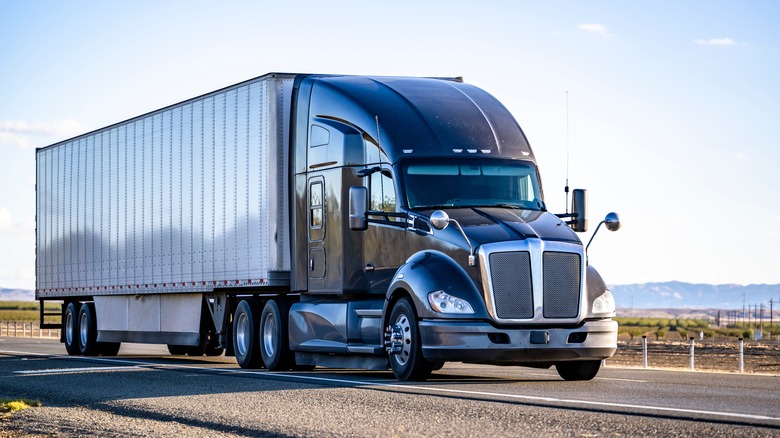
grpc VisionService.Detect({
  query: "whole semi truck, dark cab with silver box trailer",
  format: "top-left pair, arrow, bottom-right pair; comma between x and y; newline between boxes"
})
35,73 -> 620,380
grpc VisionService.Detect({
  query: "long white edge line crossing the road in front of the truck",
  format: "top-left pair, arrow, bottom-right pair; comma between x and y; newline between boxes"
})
0,350 -> 780,421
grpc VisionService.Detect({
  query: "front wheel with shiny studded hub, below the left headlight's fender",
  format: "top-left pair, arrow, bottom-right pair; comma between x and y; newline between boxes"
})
390,298 -> 434,381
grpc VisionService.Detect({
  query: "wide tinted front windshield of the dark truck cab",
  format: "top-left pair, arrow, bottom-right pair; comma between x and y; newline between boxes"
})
401,157 -> 544,210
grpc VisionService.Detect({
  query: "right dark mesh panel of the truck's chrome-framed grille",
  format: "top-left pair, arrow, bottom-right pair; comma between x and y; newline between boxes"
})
542,251 -> 581,318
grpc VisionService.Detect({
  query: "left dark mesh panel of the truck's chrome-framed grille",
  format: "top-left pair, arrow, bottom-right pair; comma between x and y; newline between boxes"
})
490,251 -> 534,319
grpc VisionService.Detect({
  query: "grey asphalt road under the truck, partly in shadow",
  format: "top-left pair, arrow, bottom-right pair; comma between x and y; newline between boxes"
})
0,338 -> 780,437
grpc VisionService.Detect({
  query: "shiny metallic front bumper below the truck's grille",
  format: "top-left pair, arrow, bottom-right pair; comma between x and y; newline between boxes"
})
420,319 -> 618,366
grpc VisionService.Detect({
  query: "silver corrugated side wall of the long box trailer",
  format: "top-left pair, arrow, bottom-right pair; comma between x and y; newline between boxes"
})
36,75 -> 293,298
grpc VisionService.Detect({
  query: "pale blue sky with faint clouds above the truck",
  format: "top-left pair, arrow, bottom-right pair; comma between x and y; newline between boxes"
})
0,0 -> 780,289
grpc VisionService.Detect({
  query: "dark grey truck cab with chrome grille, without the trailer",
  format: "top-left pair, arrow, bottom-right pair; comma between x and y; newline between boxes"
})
289,75 -> 617,380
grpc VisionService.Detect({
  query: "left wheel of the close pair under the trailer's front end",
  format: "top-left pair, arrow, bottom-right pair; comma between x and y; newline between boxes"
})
233,300 -> 263,368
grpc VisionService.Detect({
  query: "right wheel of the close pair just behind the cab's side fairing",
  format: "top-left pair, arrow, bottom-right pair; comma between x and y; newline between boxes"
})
260,298 -> 295,371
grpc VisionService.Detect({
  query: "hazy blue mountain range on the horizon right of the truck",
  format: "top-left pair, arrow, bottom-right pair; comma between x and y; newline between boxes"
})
610,281 -> 780,311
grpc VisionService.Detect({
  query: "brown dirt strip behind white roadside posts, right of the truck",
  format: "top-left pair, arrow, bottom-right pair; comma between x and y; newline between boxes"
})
606,338 -> 780,375
